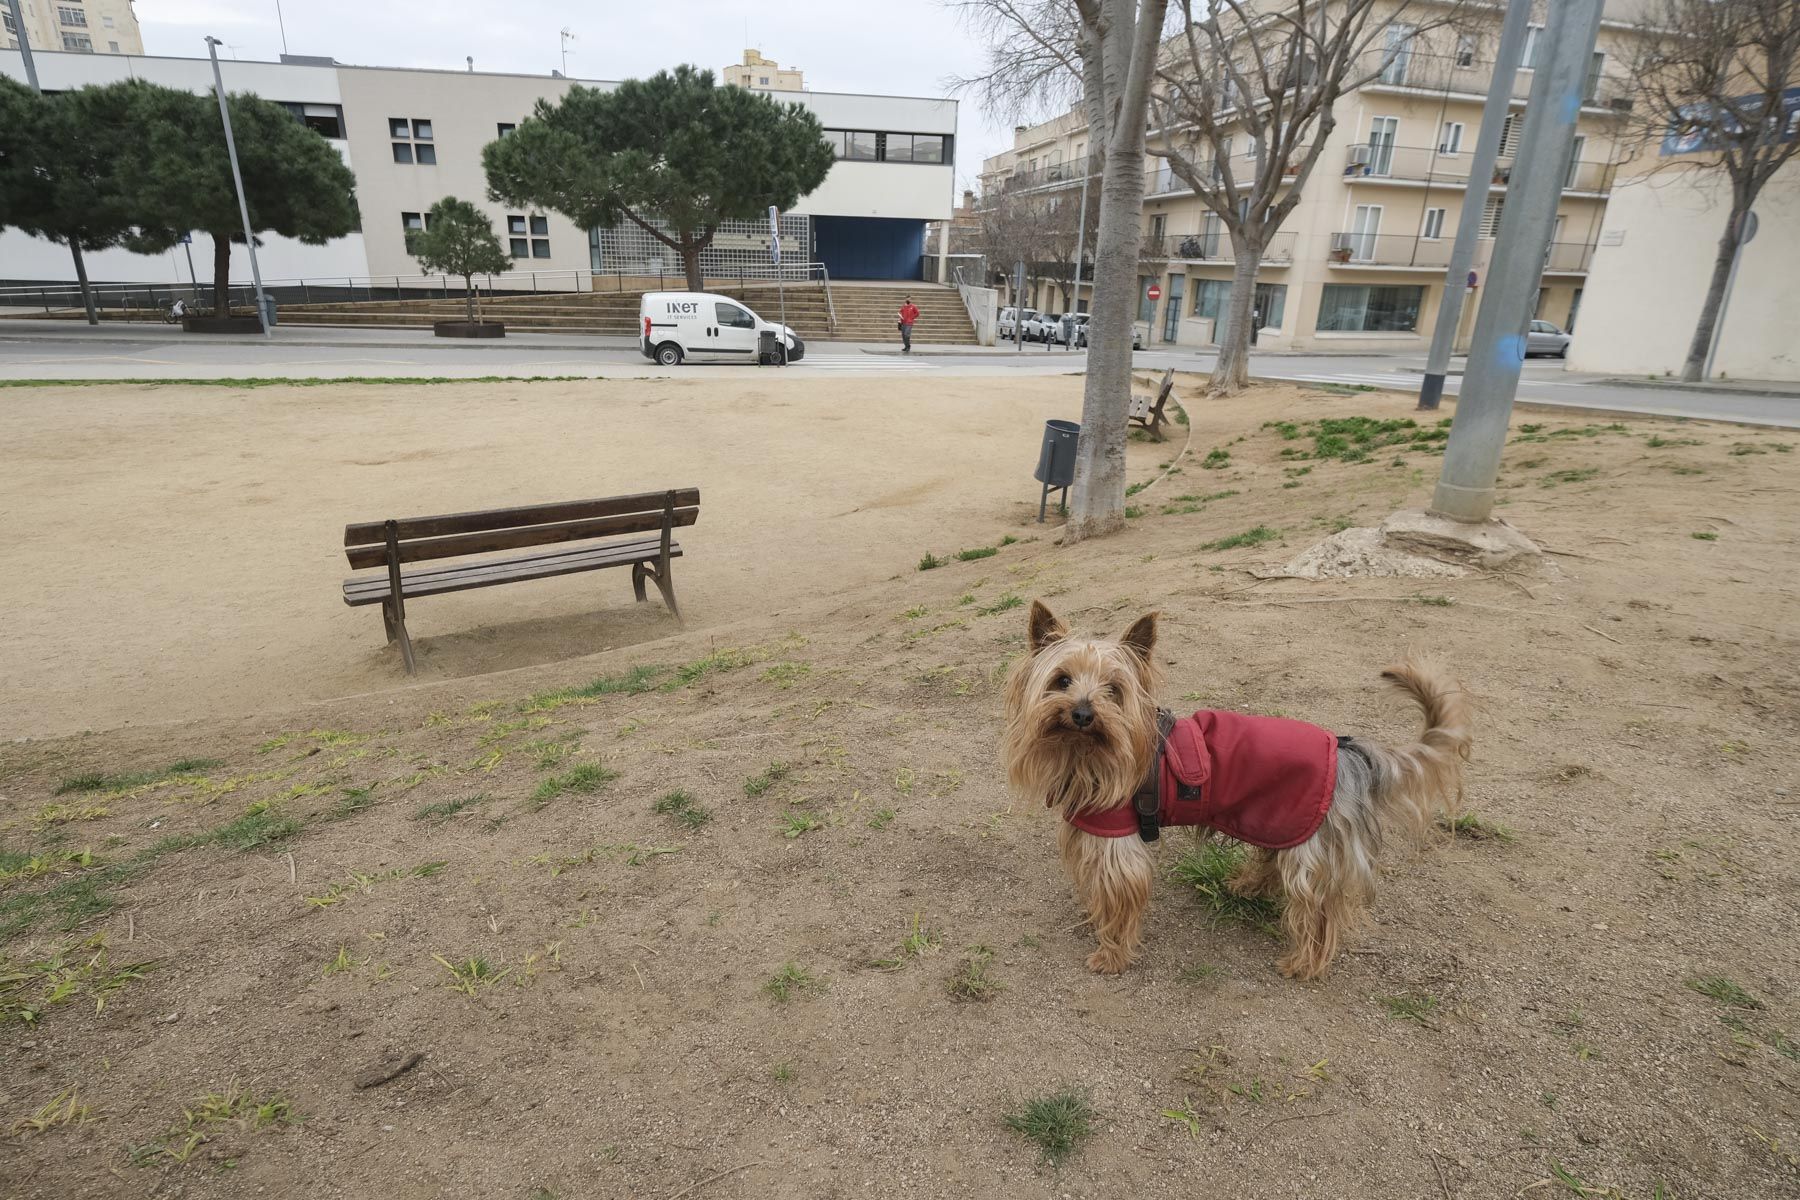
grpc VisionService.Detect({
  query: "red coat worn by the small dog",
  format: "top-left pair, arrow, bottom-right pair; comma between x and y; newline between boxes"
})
1066,709 -> 1361,849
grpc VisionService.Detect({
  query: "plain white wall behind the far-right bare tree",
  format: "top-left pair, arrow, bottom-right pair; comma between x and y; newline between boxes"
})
1570,164 -> 1800,381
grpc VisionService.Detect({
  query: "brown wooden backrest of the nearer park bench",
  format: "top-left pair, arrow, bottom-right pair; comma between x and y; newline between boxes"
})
344,488 -> 700,570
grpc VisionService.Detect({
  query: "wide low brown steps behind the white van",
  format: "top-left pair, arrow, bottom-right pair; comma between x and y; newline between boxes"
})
281,282 -> 976,345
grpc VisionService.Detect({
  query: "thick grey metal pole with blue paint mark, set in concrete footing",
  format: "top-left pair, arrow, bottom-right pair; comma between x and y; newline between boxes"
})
1431,0 -> 1602,522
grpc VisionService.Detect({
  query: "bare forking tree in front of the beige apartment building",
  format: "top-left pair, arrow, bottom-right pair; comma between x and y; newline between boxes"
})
1150,0 -> 1468,396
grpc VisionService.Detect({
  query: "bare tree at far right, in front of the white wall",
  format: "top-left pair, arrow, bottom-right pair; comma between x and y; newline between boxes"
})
1633,0 -> 1800,383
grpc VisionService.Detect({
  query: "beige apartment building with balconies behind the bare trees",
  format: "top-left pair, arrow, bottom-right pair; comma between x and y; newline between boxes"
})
981,4 -> 1633,351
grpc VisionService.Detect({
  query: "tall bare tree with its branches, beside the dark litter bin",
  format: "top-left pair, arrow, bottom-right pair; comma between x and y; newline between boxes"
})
952,0 -> 1168,542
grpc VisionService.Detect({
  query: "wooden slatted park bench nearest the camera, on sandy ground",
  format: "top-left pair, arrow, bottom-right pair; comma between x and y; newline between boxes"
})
344,488 -> 700,675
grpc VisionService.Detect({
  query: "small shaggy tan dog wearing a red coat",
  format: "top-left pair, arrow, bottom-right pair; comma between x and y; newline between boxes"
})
1003,601 -> 1471,979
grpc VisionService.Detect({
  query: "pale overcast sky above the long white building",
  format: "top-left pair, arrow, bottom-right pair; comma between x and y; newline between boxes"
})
137,0 -> 1036,187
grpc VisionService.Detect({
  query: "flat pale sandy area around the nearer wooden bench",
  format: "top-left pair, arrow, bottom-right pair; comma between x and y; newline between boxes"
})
0,370 -> 1154,738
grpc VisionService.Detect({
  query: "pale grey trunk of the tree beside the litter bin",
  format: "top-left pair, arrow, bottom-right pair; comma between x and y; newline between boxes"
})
1062,0 -> 1165,543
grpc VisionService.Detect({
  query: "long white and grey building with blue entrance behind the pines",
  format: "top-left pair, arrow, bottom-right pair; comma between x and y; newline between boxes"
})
0,50 -> 958,290
